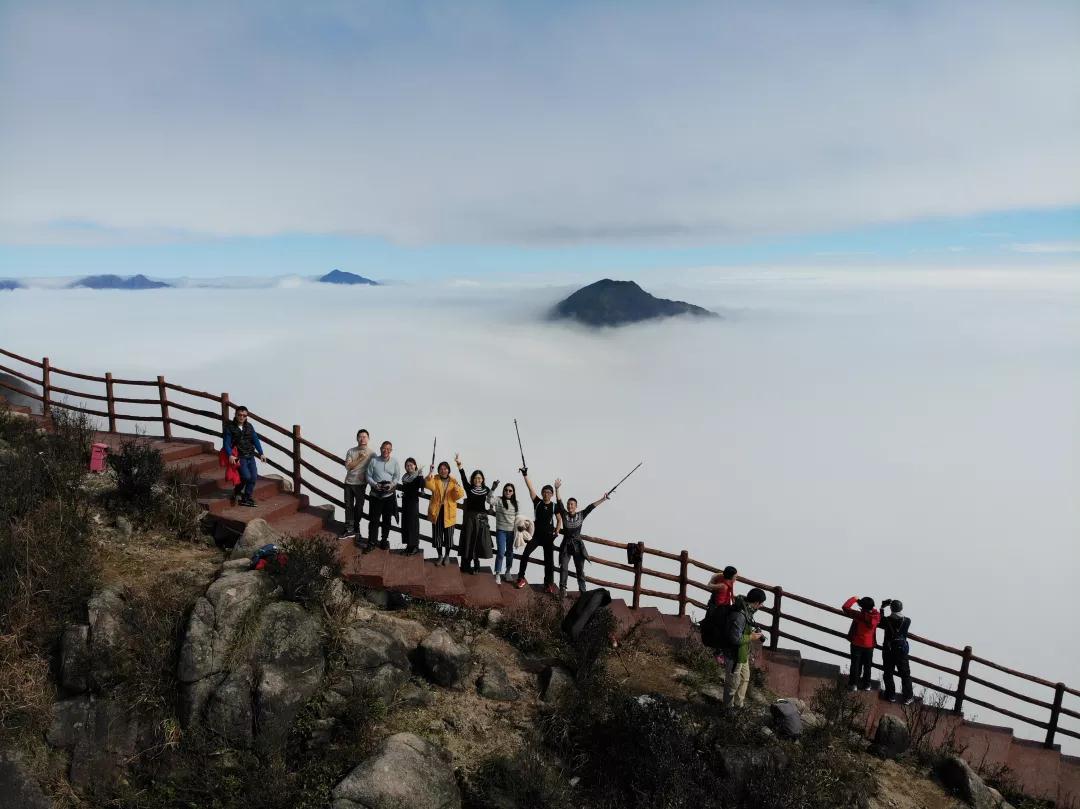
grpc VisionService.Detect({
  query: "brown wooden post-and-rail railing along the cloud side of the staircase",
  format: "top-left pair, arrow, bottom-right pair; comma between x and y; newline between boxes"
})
0,349 -> 1080,747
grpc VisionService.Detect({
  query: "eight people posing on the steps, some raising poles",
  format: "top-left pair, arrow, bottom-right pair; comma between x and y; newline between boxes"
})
342,429 -> 608,594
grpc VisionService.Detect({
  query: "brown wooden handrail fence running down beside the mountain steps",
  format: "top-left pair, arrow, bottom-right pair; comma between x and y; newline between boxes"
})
0,349 -> 1080,745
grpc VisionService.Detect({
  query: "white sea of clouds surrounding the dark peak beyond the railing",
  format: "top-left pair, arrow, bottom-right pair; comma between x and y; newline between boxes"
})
0,270 -> 1080,732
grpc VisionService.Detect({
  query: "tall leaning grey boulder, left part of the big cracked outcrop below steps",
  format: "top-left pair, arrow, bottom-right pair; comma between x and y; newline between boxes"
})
176,570 -> 273,725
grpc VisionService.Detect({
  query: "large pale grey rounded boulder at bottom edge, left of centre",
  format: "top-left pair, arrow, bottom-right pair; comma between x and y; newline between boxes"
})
332,733 -> 461,809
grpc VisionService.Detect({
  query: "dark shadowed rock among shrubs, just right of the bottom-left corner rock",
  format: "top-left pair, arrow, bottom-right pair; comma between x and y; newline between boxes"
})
45,697 -> 154,788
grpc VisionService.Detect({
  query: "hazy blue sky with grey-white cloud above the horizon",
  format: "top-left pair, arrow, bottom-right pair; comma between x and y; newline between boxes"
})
0,0 -> 1080,280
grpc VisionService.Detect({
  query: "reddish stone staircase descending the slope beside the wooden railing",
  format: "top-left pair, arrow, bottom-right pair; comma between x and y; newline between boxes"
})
39,429 -> 1080,809
